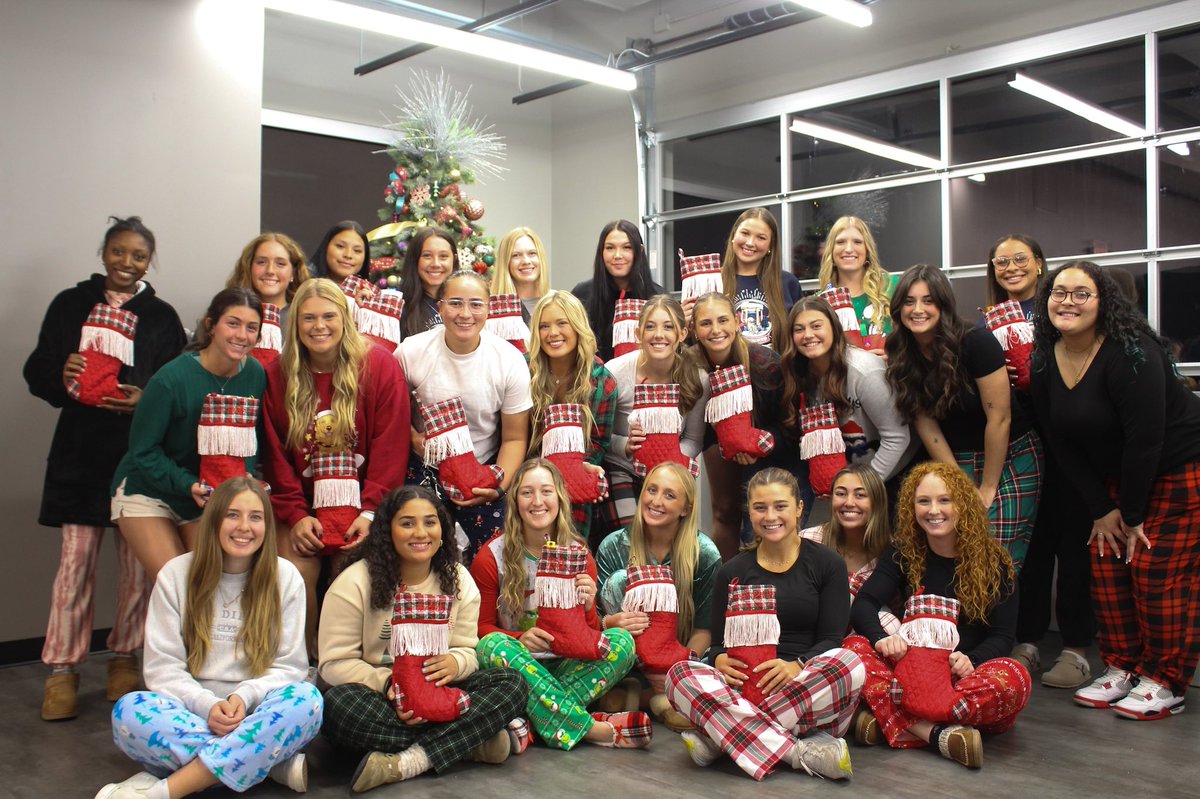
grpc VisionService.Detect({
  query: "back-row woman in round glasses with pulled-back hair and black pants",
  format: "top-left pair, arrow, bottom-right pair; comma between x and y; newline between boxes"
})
988,233 -> 1096,689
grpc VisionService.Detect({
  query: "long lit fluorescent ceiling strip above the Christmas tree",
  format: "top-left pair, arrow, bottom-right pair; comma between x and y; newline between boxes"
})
263,0 -> 637,91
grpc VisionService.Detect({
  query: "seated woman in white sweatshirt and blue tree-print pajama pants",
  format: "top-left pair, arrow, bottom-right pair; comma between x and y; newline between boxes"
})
96,477 -> 323,799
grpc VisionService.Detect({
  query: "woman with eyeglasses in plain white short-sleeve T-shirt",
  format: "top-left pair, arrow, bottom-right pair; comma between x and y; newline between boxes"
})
396,269 -> 533,564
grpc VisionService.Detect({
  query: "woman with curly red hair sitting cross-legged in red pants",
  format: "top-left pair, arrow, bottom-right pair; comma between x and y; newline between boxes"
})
845,462 -> 1031,769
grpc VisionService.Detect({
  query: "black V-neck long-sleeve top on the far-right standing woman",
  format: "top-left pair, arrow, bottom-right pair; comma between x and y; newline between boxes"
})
1031,336 -> 1200,525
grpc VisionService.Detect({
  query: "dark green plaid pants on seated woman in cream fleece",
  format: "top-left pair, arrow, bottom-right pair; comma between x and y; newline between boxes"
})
322,668 -> 527,774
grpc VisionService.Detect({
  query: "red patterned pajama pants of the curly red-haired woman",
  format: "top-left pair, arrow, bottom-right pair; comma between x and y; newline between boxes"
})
845,636 -> 1032,749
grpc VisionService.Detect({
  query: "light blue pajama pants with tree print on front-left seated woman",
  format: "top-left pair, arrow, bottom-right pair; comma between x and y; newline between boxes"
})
113,683 -> 322,792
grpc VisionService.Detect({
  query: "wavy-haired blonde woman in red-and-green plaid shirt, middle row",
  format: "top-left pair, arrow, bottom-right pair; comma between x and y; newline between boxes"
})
529,292 -> 617,544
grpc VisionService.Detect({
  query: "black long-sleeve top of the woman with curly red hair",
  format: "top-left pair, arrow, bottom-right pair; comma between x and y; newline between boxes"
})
850,546 -> 1018,666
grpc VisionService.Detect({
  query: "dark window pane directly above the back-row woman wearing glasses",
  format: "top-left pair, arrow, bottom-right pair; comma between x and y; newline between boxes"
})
950,151 -> 1146,265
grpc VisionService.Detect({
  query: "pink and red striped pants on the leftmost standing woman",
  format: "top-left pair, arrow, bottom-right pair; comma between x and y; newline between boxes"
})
42,524 -> 148,666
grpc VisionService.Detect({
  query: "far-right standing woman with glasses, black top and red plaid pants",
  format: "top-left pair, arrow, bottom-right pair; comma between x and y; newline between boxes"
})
1032,260 -> 1200,720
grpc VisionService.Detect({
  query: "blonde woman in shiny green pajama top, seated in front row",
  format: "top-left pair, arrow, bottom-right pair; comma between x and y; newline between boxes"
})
596,463 -> 721,729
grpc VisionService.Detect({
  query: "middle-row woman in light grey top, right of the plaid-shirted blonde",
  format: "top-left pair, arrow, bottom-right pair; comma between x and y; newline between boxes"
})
598,294 -> 708,535
